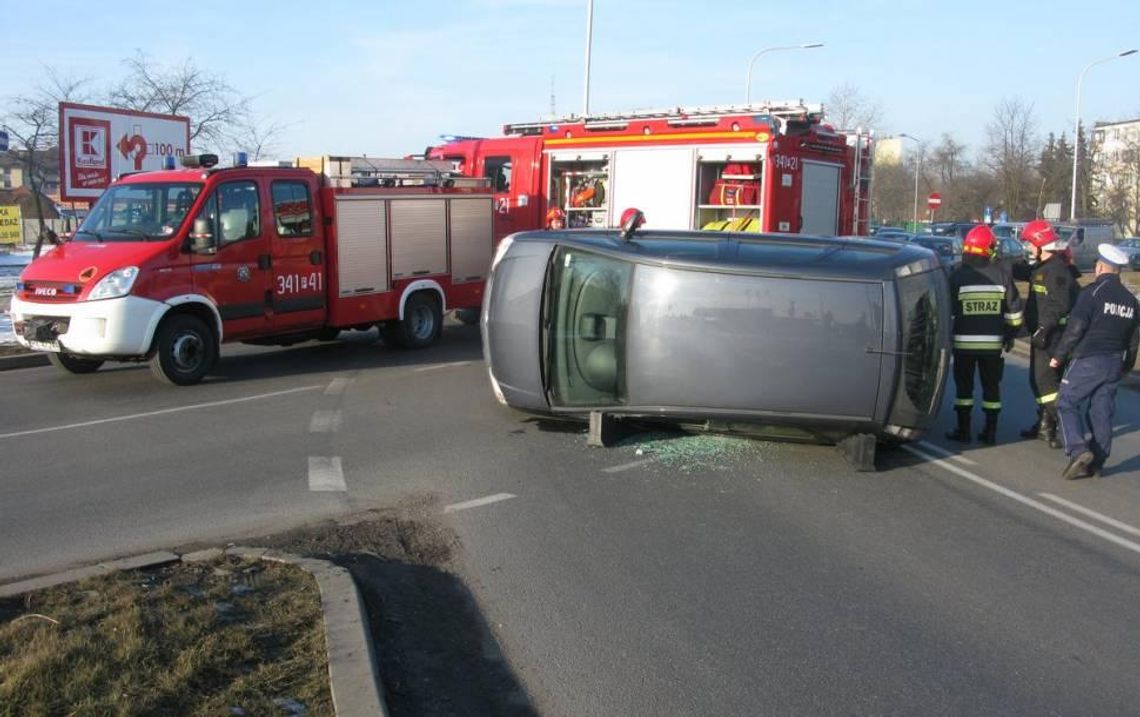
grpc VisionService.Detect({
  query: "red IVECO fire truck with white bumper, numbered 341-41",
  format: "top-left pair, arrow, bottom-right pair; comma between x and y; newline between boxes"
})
10,155 -> 494,384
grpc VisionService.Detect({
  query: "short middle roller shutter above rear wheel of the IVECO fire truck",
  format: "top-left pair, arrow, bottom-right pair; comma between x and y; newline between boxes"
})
389,198 -> 447,279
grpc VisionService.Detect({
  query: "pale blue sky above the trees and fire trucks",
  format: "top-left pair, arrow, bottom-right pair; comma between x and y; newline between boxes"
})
0,0 -> 1140,158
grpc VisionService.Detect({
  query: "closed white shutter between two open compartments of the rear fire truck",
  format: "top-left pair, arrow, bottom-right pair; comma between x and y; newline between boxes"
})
610,147 -> 697,229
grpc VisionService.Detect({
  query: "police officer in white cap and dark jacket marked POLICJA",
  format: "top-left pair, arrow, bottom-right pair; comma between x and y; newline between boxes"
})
1051,244 -> 1140,480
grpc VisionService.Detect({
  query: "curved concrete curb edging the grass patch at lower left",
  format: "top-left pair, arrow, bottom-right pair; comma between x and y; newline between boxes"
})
0,546 -> 388,717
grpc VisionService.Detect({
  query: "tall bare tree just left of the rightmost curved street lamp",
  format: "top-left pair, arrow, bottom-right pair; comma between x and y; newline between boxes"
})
984,98 -> 1040,219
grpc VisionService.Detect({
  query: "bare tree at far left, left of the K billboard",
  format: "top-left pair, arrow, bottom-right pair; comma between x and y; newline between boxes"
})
0,67 -> 88,256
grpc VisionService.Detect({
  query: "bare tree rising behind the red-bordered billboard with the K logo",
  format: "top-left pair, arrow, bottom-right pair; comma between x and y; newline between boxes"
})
108,50 -> 250,149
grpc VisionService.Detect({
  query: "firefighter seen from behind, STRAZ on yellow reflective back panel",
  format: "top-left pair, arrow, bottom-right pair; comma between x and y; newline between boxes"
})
946,225 -> 1023,446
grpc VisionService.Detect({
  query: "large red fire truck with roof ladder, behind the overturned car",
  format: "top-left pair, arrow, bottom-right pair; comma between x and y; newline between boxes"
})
428,103 -> 872,241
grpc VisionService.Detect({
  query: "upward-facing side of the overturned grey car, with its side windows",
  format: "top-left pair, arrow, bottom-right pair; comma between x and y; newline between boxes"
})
513,229 -> 937,279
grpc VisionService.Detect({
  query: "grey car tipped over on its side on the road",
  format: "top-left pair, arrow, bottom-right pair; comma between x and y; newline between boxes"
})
482,224 -> 950,465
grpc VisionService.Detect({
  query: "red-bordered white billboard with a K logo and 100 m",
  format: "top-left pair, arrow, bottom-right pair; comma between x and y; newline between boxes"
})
59,103 -> 190,202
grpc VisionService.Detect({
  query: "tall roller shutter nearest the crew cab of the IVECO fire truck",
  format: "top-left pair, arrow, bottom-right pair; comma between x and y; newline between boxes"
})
336,197 -> 388,298
